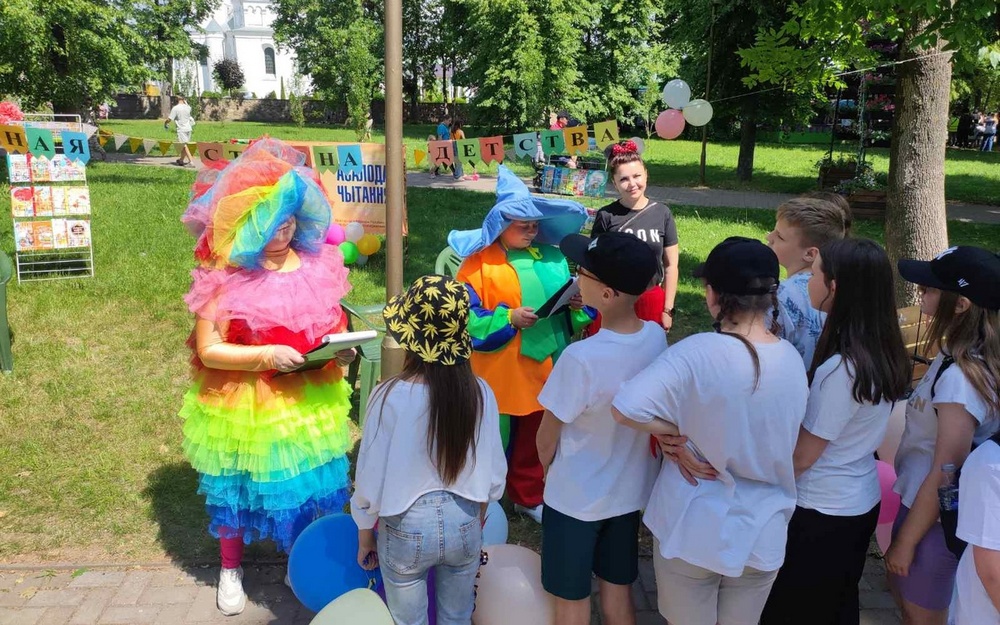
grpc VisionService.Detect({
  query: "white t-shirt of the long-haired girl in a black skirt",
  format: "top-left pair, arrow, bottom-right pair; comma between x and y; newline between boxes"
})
796,354 -> 892,516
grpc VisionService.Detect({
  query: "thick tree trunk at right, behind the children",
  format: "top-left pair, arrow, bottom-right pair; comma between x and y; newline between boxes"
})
885,23 -> 951,306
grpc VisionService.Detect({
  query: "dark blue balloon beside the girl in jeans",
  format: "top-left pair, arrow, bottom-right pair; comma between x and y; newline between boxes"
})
288,513 -> 380,612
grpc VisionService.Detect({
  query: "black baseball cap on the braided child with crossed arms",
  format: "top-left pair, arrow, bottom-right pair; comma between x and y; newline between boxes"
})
694,237 -> 779,295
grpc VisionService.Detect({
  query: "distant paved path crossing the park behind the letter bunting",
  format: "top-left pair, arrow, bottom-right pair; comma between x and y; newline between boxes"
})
108,152 -> 1000,224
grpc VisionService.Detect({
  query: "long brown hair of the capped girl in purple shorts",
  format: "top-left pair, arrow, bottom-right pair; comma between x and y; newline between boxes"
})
926,291 -> 1000,414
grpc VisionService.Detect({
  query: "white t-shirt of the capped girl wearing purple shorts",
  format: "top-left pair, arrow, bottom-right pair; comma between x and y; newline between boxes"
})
893,353 -> 1000,508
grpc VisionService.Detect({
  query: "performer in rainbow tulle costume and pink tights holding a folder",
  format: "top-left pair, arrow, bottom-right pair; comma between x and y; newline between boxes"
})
180,139 -> 353,615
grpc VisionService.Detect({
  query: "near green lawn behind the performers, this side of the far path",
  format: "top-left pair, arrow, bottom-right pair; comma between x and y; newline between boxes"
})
0,163 -> 1000,563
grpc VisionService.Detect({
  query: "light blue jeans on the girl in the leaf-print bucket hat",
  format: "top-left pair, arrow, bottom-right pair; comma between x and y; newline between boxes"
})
378,491 -> 483,625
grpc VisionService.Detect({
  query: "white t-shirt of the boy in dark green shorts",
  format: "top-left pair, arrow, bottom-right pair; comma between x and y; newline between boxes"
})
538,321 -> 667,521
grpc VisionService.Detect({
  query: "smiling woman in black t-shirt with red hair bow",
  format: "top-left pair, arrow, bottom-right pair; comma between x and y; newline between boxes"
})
589,141 -> 680,334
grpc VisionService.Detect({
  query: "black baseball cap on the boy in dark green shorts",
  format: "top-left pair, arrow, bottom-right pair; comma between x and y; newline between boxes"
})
559,232 -> 660,295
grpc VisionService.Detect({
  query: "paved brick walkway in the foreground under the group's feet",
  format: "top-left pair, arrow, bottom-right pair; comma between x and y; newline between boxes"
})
0,556 -> 900,625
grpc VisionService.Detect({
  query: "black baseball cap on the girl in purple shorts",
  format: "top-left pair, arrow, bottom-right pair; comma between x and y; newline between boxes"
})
899,245 -> 1000,310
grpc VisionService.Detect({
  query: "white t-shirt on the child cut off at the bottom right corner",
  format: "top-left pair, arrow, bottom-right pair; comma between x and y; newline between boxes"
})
952,442 -> 1000,625
